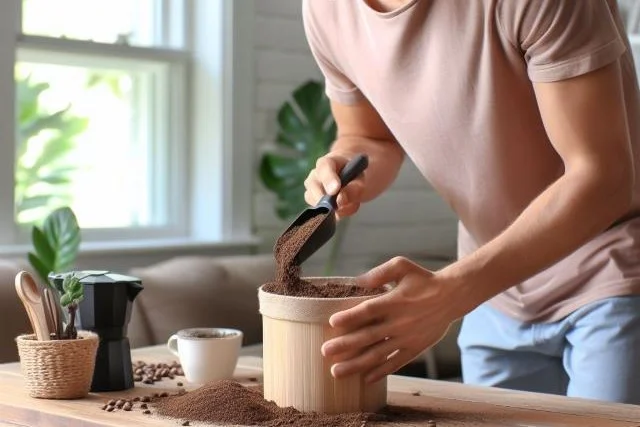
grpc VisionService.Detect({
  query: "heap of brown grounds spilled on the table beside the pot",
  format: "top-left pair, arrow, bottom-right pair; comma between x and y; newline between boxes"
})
154,380 -> 370,427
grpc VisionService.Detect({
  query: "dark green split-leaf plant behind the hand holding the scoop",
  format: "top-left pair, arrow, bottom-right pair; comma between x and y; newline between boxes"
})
259,80 -> 348,275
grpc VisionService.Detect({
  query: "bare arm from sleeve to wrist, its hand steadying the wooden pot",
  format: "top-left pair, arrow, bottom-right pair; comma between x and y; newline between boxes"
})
439,62 -> 634,304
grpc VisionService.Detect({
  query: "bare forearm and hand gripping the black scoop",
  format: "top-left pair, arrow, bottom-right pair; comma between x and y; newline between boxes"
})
305,99 -> 404,216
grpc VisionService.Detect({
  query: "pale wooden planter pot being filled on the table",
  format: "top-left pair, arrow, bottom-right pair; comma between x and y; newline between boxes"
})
258,277 -> 387,414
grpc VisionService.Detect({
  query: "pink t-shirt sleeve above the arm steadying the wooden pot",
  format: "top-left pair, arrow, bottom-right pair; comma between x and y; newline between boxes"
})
497,0 -> 626,82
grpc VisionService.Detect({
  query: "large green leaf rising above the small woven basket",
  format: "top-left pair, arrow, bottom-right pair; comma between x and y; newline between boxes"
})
28,207 -> 81,290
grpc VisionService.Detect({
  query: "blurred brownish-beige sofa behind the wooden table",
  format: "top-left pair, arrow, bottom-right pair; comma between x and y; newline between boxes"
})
0,254 -> 459,378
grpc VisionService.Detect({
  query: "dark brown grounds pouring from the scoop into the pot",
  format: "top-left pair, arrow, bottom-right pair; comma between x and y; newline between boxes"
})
264,214 -> 382,298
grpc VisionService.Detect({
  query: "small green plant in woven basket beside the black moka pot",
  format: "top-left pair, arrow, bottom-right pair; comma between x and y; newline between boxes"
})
16,208 -> 98,399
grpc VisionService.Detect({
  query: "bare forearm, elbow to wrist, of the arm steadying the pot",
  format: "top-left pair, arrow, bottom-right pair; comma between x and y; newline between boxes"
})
438,168 -> 631,314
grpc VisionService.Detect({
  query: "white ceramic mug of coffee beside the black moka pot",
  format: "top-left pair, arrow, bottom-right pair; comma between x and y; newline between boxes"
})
167,328 -> 243,384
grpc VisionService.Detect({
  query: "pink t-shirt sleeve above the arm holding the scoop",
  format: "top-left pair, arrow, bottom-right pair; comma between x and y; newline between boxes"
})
302,0 -> 363,104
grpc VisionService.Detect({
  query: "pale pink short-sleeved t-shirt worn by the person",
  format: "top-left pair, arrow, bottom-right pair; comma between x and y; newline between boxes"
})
303,0 -> 640,321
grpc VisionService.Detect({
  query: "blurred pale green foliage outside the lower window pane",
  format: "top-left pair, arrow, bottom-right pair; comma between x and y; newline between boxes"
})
15,77 -> 88,224
